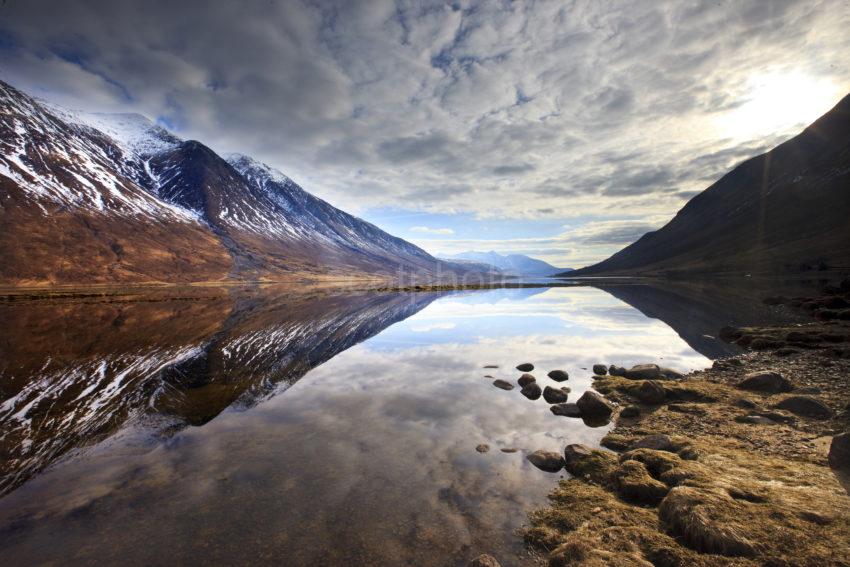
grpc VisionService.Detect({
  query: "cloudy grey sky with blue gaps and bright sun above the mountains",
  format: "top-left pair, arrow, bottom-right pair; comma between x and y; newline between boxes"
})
0,0 -> 850,267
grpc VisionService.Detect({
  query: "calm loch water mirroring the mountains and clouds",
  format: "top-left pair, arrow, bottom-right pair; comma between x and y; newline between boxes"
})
0,286 -> 812,566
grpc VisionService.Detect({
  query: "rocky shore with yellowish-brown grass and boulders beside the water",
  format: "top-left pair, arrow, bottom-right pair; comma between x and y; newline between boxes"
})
523,283 -> 850,567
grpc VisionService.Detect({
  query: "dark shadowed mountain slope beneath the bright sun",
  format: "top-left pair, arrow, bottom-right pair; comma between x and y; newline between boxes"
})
570,95 -> 850,276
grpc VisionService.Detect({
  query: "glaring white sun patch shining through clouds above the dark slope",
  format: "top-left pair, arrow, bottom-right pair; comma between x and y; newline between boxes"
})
719,73 -> 843,140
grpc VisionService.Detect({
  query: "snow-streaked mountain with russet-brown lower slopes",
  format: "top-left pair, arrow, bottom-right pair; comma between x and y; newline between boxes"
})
0,82 -> 475,285
